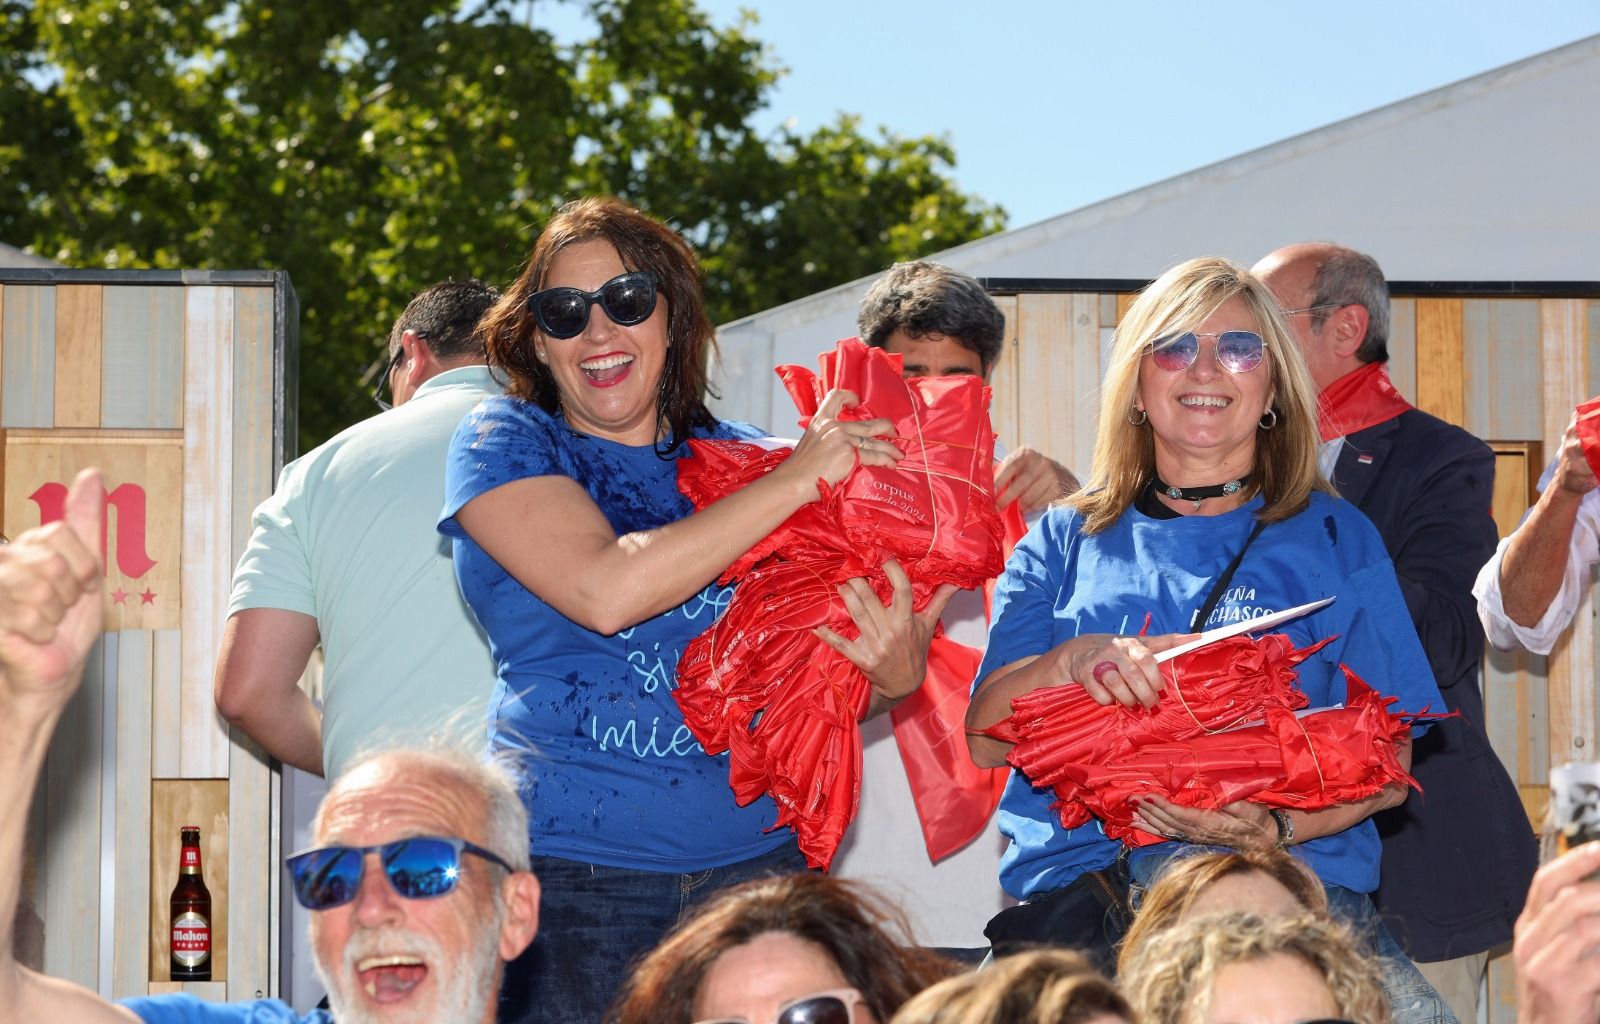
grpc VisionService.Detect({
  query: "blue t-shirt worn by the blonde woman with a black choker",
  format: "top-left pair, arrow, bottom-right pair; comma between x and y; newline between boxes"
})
978,493 -> 1445,899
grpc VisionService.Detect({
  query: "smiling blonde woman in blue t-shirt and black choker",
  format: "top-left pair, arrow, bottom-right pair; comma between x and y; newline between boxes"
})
968,259 -> 1448,1021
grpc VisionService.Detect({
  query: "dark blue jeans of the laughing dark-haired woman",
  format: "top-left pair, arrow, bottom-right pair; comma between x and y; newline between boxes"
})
498,840 -> 806,1024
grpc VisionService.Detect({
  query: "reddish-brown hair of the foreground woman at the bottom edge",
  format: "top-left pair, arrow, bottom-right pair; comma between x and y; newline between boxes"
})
605,875 -> 954,1024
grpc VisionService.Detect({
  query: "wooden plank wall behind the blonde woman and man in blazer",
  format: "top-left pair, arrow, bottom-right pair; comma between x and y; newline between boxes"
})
992,286 -> 1600,1024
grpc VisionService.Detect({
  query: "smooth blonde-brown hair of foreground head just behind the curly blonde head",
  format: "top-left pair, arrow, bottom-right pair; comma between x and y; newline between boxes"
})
1117,850 -> 1328,973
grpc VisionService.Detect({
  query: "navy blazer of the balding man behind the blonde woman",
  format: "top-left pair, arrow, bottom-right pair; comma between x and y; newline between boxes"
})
1334,410 -> 1539,962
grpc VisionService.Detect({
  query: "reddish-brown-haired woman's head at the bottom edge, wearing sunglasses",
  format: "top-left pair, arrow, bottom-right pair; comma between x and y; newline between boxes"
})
608,875 -> 950,1024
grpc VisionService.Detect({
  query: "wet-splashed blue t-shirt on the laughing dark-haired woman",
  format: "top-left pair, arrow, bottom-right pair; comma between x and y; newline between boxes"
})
438,397 -> 789,872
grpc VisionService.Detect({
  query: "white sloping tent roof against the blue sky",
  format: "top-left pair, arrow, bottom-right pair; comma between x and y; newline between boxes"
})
717,35 -> 1600,430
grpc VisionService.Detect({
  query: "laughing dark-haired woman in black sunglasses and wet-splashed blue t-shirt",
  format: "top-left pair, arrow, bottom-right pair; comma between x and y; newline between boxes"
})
440,198 -> 942,1024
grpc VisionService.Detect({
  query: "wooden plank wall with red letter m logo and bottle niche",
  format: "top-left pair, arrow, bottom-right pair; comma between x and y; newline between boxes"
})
0,282 -> 284,998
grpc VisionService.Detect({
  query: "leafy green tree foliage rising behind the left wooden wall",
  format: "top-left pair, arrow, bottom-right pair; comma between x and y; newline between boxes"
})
0,0 -> 1005,446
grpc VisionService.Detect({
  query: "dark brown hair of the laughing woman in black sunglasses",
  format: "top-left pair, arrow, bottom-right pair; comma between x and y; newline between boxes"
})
478,195 -> 717,442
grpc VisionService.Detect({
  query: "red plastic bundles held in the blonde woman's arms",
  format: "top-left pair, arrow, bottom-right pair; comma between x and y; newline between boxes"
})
987,634 -> 1437,846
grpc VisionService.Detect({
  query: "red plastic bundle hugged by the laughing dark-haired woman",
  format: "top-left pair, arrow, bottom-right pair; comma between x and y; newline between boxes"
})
674,338 -> 1003,867
